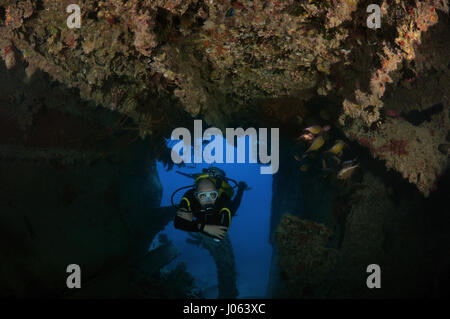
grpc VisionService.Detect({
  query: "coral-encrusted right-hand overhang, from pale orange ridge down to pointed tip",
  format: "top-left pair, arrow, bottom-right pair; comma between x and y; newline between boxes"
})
340,1 -> 450,196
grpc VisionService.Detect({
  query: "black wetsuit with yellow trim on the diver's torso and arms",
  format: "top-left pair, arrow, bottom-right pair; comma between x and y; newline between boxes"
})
174,186 -> 244,238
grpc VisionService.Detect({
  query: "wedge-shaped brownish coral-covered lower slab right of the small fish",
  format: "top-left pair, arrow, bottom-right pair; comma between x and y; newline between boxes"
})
348,109 -> 450,196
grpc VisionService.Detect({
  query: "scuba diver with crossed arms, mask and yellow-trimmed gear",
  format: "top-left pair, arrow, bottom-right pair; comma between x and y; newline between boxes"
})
172,167 -> 249,242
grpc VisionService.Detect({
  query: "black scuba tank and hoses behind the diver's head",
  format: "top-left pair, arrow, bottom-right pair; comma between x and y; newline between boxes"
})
170,166 -> 238,209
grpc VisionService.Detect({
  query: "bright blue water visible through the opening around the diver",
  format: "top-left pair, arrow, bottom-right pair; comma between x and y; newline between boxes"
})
150,134 -> 272,298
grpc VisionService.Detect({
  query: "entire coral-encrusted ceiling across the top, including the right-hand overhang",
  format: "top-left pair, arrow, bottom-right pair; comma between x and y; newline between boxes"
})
0,0 -> 449,194
